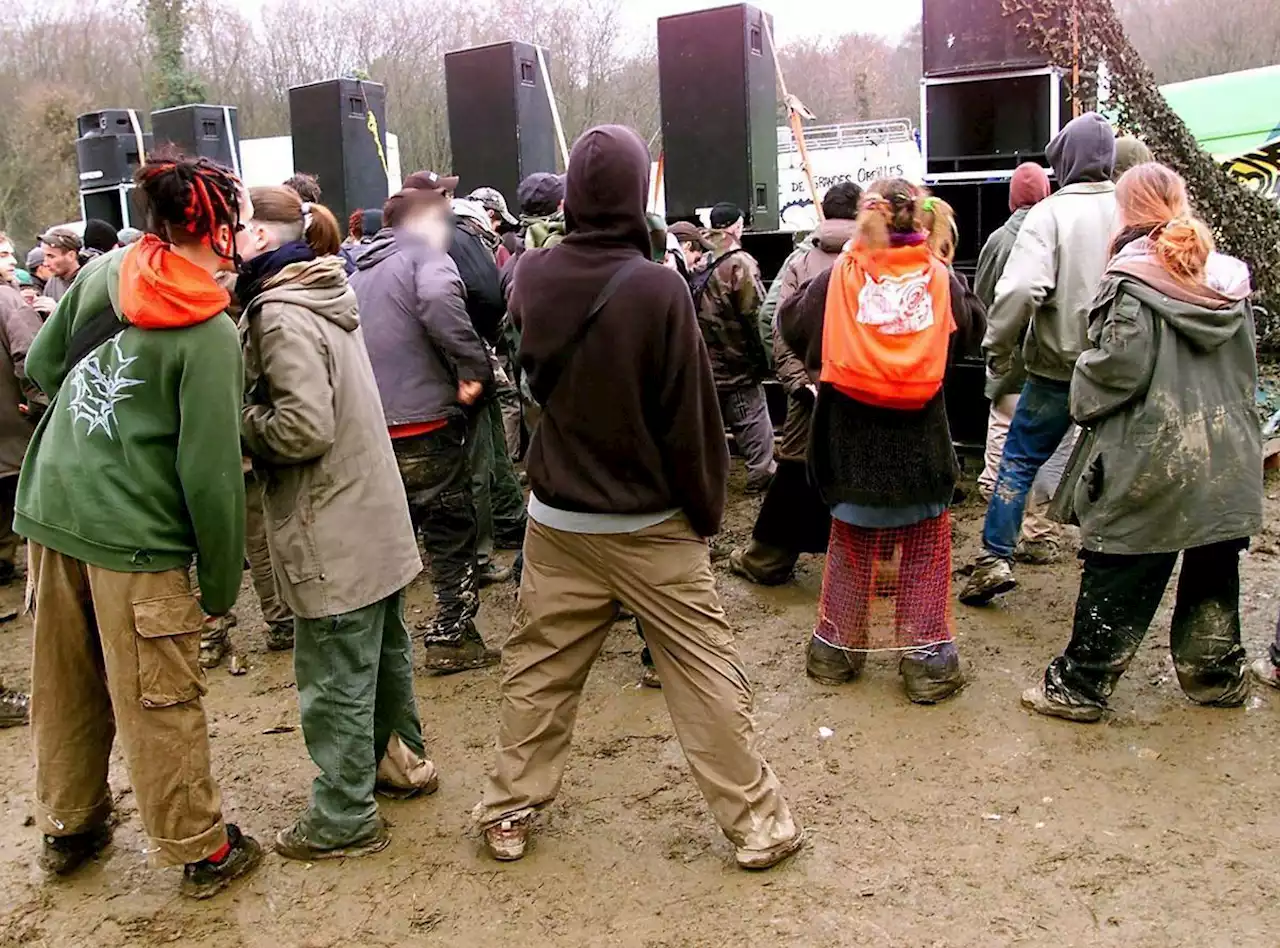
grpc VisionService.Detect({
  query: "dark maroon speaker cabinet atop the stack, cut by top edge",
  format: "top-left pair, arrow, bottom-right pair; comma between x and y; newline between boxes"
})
923,0 -> 1068,75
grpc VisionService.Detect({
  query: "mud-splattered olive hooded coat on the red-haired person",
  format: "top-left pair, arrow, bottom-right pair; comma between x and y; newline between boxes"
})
1064,264 -> 1262,554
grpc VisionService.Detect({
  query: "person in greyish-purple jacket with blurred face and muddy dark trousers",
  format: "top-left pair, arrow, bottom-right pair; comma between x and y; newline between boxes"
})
351,182 -> 499,673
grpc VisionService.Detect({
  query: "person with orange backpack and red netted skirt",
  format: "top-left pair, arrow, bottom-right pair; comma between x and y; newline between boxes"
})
778,179 -> 986,704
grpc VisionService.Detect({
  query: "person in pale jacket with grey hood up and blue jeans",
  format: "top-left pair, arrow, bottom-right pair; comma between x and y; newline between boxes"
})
960,113 -> 1116,605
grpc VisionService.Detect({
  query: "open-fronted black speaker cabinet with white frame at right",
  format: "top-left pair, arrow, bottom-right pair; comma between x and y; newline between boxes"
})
924,70 -> 1071,174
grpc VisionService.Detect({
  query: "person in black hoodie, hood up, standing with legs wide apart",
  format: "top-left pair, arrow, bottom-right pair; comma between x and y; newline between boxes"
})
475,125 -> 804,869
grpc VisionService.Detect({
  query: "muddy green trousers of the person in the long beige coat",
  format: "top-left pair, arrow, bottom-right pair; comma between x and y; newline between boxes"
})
293,590 -> 422,849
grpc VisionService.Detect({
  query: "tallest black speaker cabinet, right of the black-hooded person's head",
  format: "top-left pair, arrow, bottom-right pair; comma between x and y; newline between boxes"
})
658,4 -> 778,230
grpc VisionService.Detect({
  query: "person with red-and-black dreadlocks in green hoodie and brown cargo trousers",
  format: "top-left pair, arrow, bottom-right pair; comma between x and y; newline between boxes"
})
14,157 -> 262,898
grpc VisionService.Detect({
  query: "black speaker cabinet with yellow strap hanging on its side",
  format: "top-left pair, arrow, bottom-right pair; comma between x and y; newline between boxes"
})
289,79 -> 387,221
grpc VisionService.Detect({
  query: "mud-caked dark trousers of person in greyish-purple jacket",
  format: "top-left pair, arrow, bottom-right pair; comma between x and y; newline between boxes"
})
392,421 -> 480,642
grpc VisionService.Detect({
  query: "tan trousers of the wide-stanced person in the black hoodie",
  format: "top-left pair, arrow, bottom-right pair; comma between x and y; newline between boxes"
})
476,516 -> 796,849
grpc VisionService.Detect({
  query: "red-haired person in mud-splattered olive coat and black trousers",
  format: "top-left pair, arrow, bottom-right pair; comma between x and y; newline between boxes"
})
1023,162 -> 1262,722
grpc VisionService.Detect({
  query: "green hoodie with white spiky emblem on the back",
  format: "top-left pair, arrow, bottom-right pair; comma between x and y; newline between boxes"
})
14,251 -> 244,615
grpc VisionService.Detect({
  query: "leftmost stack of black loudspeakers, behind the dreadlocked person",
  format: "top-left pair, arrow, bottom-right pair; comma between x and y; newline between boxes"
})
76,109 -> 151,230
